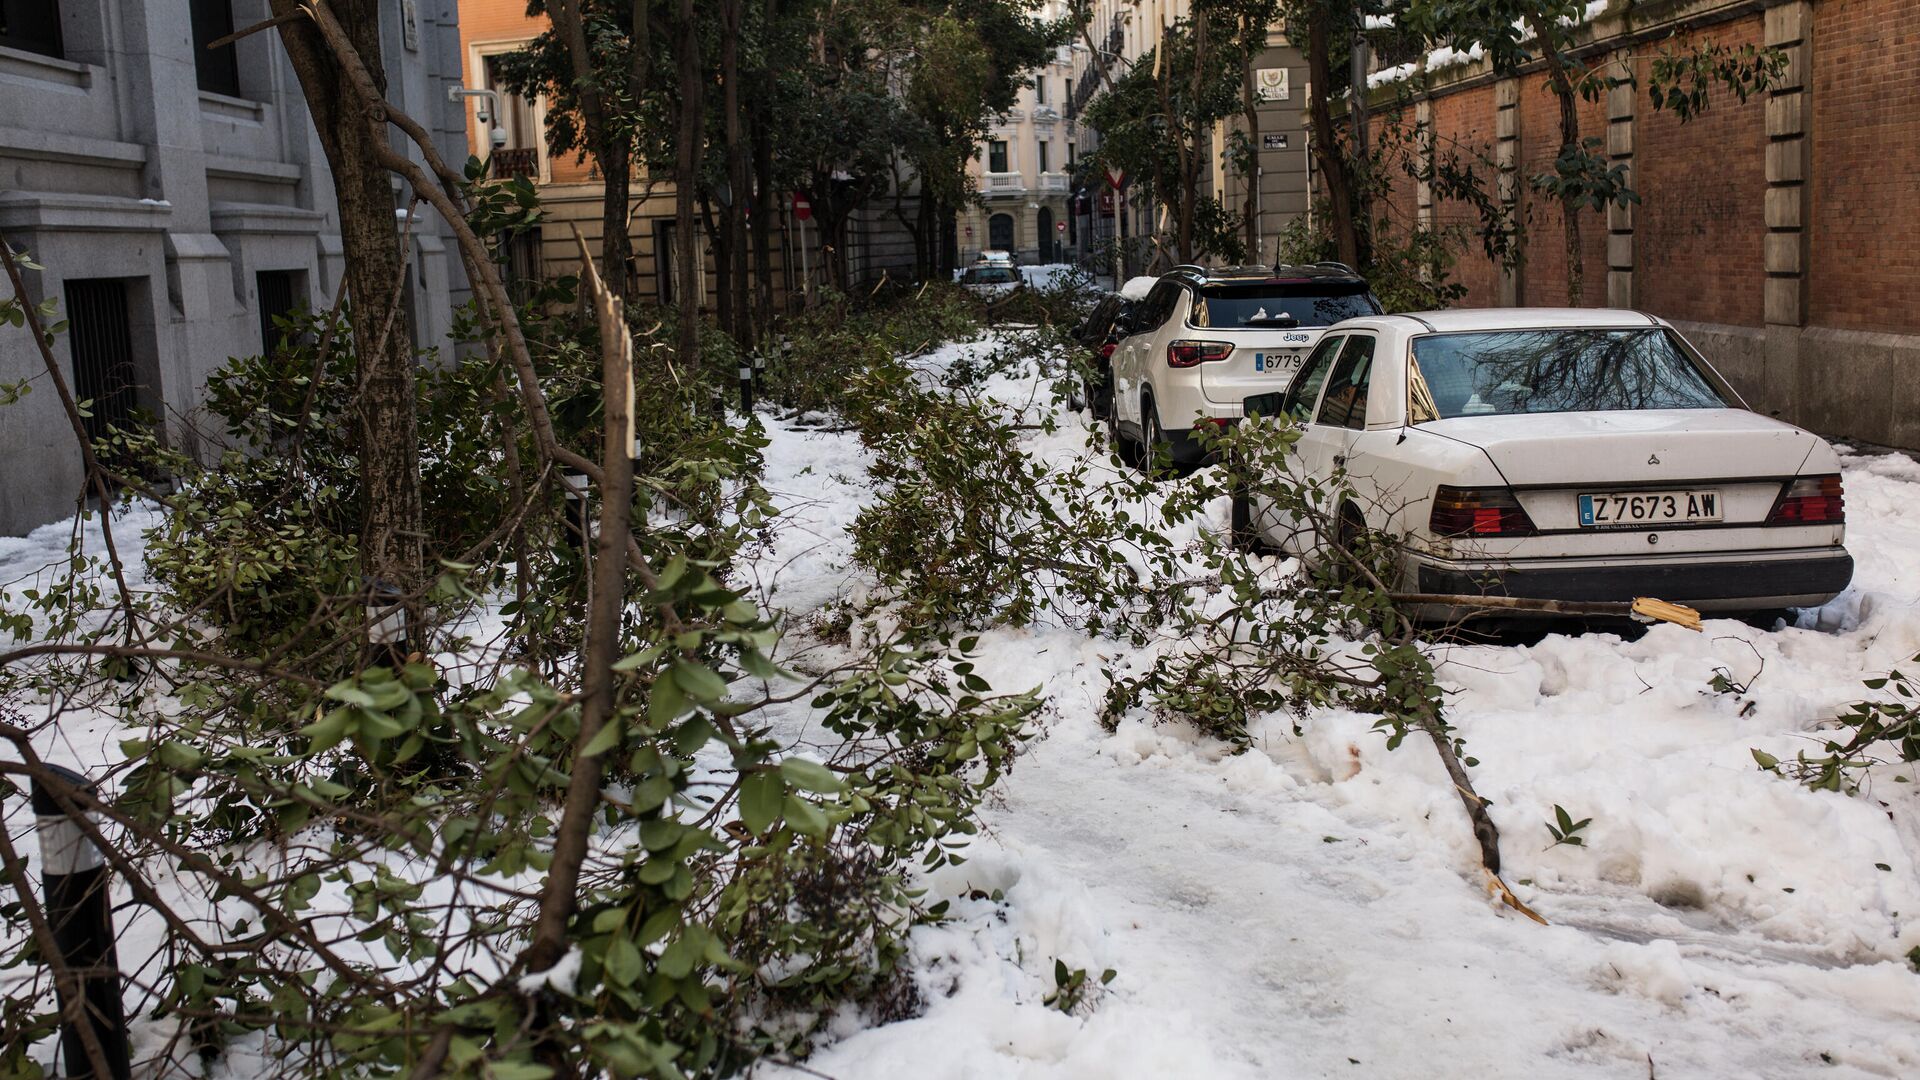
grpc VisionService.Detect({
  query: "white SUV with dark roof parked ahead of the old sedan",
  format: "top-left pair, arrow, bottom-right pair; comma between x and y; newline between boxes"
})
1108,263 -> 1380,467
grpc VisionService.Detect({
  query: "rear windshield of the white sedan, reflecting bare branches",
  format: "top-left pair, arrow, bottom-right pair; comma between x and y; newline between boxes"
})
1407,327 -> 1728,423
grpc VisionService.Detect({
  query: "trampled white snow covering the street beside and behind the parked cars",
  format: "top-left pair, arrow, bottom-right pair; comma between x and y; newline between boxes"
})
752,332 -> 1920,1080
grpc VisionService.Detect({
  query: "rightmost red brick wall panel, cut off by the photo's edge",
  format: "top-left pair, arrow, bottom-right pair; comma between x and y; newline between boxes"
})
1807,0 -> 1920,332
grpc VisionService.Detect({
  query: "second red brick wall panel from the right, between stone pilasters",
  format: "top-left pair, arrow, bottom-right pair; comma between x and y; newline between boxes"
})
1632,13 -> 1766,327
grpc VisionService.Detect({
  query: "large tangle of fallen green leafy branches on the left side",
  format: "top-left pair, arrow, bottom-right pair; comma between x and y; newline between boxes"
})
0,242 -> 1037,1078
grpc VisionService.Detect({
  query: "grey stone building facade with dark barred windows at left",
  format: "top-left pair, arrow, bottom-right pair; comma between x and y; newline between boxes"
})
0,0 -> 467,534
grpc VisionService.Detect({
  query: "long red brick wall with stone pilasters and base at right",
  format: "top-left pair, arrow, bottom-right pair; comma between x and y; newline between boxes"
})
1371,0 -> 1920,448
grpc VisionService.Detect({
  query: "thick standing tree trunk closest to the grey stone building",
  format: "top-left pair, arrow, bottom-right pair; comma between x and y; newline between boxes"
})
273,0 -> 426,642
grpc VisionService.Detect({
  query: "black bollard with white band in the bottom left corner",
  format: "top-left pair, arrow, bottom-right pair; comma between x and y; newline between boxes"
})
33,765 -> 132,1080
